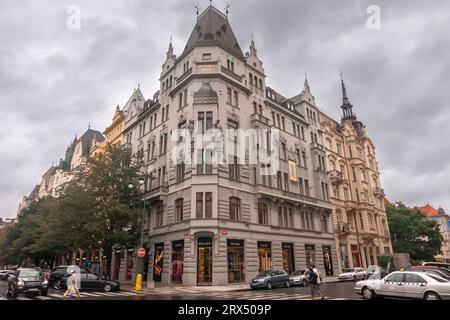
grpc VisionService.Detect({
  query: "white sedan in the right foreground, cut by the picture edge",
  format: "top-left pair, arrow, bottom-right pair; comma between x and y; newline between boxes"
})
355,271 -> 450,300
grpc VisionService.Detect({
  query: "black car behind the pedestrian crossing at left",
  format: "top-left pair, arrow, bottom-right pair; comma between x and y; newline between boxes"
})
49,266 -> 120,292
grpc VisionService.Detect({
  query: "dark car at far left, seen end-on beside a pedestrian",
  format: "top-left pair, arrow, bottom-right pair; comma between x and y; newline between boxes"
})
7,268 -> 48,298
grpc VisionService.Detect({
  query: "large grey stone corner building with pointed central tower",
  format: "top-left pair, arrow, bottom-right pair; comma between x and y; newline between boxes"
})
117,6 -> 338,285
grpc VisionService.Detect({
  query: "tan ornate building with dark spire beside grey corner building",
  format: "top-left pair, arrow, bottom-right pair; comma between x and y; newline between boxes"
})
320,76 -> 392,270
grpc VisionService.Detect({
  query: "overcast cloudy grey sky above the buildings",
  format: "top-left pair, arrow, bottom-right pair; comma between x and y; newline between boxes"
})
0,0 -> 450,218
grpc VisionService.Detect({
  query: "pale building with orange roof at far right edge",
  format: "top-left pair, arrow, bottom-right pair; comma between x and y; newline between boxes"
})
417,204 -> 450,262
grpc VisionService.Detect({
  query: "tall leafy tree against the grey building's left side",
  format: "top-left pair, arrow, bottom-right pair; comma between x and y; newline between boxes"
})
64,144 -> 142,276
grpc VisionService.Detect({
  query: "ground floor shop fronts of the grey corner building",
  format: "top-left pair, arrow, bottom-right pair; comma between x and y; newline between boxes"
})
135,232 -> 337,286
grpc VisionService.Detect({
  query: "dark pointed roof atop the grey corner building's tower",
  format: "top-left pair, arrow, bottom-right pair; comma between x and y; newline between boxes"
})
183,5 -> 244,59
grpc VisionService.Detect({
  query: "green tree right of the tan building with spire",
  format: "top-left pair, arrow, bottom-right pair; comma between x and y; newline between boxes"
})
386,202 -> 443,261
